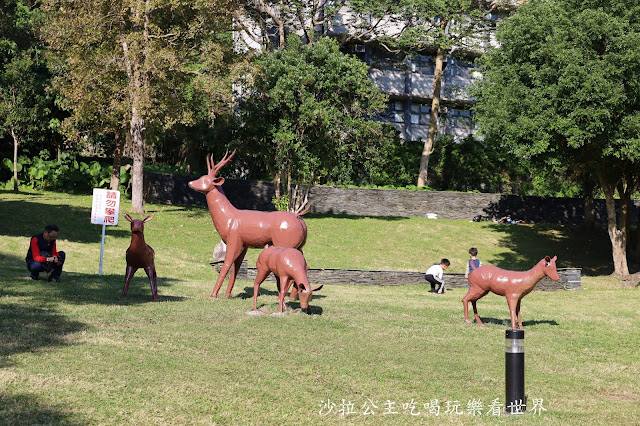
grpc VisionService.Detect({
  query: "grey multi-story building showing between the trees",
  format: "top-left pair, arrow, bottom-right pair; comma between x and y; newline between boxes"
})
236,0 -> 521,141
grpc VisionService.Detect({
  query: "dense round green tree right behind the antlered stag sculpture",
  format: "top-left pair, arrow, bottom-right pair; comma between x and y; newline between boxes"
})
242,36 -> 395,212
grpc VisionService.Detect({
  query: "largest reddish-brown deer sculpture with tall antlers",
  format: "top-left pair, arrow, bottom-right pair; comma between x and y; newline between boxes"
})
189,151 -> 307,297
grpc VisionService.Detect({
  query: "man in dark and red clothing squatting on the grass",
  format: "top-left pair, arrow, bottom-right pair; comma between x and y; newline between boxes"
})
25,225 -> 65,283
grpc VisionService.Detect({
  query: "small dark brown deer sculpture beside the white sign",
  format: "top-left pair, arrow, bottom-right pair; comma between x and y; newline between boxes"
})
122,214 -> 159,301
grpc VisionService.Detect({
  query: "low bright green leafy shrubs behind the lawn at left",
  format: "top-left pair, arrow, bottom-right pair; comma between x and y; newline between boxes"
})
2,151 -> 129,192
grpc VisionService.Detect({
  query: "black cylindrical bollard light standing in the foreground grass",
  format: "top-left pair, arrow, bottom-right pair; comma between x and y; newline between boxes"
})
504,330 -> 526,414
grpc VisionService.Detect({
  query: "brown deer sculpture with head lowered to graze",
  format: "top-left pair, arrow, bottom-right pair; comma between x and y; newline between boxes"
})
253,246 -> 322,315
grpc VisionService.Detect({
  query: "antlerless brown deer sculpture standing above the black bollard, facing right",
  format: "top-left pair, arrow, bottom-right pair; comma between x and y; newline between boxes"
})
462,256 -> 560,330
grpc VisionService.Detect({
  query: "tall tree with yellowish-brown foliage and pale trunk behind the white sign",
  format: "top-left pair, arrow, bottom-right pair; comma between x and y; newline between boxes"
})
44,0 -> 232,212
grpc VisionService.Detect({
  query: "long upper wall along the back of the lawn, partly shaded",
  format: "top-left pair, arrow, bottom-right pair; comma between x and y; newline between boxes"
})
144,172 -> 640,224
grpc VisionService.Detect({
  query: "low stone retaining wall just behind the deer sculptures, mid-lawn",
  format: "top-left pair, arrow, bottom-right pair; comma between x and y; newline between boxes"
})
225,261 -> 581,291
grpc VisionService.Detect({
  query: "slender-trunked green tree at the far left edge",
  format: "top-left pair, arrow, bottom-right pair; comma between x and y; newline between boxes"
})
0,1 -> 53,191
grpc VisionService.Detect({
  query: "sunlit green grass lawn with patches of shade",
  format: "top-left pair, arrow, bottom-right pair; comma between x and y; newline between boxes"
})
0,191 -> 640,425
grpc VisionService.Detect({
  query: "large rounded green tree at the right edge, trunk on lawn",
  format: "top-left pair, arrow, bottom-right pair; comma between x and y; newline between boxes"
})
476,0 -> 640,275
